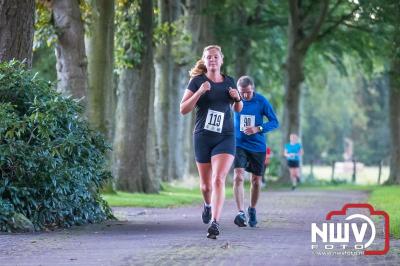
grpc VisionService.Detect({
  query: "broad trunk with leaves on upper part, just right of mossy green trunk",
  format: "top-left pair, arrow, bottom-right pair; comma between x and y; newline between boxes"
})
113,0 -> 158,193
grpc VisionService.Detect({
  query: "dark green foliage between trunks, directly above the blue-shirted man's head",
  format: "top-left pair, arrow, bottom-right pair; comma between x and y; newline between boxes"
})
214,0 -> 288,109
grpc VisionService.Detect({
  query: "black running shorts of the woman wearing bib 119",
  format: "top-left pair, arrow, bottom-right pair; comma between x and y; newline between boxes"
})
193,134 -> 236,163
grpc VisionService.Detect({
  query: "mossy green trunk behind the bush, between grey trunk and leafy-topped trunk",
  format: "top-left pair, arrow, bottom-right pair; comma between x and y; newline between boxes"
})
86,0 -> 115,137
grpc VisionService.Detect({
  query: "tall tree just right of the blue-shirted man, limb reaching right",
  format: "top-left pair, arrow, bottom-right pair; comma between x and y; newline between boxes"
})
280,0 -> 360,182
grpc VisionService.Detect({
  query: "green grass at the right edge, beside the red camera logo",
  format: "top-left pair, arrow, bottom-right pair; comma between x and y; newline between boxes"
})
369,186 -> 400,239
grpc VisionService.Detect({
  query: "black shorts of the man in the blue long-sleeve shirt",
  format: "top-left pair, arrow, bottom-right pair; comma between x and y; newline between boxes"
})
233,147 -> 266,176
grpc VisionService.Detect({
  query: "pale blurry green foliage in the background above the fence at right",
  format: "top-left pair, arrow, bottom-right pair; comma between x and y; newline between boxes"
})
302,57 -> 389,165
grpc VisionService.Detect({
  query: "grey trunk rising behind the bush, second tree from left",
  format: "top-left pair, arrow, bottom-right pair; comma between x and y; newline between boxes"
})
53,0 -> 87,102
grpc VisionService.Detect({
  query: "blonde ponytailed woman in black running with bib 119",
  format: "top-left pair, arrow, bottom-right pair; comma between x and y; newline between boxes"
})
180,45 -> 243,239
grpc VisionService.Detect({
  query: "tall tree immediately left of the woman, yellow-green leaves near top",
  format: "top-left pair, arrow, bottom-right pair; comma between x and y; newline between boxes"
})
155,0 -> 209,180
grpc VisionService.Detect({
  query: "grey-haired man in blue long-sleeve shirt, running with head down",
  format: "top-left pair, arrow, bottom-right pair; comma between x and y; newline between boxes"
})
233,76 -> 279,227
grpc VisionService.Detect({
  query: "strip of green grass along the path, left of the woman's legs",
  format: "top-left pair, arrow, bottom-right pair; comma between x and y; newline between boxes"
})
102,184 -> 233,208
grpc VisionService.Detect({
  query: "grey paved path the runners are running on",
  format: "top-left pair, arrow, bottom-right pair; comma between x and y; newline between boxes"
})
0,191 -> 400,266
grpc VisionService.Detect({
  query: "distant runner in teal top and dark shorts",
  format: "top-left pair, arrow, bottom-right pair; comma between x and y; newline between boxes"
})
284,134 -> 304,190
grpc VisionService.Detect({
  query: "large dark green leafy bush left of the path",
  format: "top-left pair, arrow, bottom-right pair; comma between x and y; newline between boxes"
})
0,61 -> 112,231
